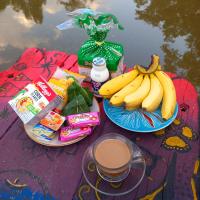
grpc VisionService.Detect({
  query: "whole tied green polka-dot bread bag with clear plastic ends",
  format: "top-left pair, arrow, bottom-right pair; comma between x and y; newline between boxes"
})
57,9 -> 124,80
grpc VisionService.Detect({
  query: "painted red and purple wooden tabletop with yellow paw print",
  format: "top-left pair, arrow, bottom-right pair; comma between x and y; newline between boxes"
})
0,48 -> 200,200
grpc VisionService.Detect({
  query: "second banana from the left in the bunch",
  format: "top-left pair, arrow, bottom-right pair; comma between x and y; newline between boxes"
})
110,74 -> 143,106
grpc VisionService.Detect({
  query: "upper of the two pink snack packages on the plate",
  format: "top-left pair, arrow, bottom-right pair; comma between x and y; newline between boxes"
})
66,112 -> 100,127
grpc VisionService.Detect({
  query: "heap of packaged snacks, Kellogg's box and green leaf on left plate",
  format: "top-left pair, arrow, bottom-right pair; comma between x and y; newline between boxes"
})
9,68 -> 100,142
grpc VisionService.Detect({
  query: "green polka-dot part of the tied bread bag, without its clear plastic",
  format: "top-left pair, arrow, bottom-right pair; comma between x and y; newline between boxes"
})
75,13 -> 124,72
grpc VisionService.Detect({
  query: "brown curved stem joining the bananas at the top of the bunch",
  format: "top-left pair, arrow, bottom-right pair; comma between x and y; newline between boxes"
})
135,54 -> 160,74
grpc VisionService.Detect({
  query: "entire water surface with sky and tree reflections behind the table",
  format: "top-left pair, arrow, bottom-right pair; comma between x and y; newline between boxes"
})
0,0 -> 200,93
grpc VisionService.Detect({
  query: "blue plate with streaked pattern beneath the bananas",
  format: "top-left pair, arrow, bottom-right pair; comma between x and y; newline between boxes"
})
103,99 -> 178,132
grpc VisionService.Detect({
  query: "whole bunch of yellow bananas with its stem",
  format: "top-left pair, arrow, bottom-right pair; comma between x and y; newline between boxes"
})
99,55 -> 176,120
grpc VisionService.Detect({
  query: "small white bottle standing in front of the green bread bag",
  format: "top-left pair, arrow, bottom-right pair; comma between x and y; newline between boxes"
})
90,57 -> 109,96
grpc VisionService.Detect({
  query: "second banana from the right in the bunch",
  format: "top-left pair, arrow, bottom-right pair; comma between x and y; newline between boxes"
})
142,74 -> 163,112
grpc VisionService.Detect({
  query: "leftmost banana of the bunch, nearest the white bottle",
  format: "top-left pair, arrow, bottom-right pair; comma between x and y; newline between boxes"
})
99,69 -> 138,96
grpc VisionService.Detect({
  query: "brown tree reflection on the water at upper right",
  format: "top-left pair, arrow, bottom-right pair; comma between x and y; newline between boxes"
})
135,0 -> 200,92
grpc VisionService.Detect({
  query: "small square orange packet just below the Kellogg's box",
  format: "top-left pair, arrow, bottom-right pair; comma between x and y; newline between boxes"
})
40,111 -> 65,131
